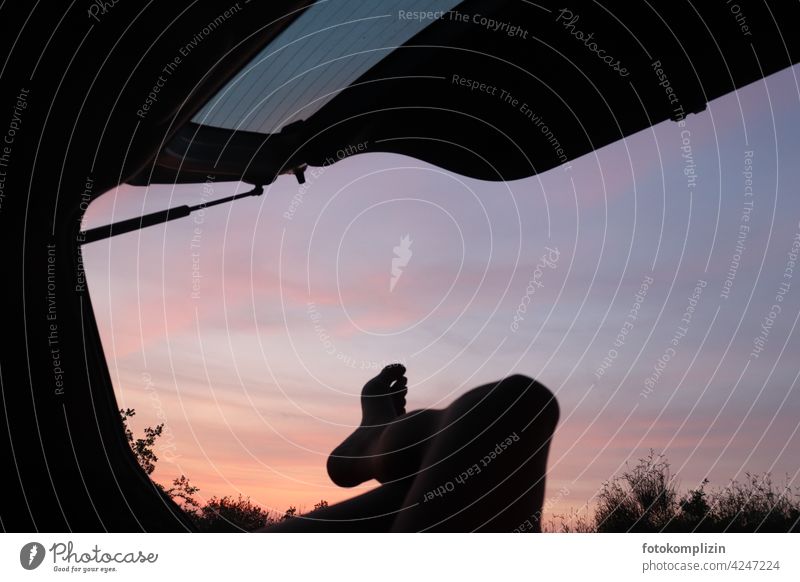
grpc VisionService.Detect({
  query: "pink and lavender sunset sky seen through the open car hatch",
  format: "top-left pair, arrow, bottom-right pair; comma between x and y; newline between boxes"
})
84,62 -> 800,515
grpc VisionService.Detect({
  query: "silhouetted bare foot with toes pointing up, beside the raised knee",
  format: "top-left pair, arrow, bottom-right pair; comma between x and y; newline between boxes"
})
327,364 -> 408,487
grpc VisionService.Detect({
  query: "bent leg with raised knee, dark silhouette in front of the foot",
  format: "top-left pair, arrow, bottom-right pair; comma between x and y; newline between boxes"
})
393,375 -> 559,532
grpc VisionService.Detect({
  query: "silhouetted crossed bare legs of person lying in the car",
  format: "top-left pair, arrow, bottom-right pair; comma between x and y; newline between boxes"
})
267,364 -> 559,532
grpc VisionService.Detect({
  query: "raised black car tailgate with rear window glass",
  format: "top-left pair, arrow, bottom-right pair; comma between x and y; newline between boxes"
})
129,0 -> 800,184
